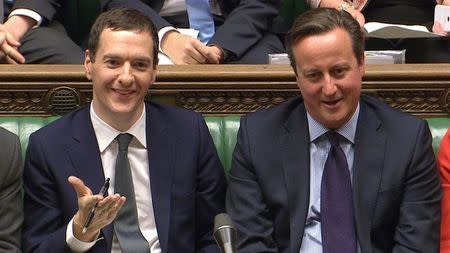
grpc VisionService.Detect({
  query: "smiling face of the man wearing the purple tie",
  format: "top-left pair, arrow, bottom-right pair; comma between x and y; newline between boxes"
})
293,29 -> 364,129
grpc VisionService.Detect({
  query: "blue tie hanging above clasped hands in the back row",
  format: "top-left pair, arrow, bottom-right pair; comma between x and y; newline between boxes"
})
186,0 -> 214,44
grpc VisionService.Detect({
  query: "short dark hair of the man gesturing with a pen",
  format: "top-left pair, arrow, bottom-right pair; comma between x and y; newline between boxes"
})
88,8 -> 159,68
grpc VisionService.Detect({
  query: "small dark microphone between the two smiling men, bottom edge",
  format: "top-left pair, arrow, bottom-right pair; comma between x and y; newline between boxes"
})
213,213 -> 237,253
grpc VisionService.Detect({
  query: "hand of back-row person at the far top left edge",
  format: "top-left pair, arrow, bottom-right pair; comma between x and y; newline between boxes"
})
0,16 -> 36,64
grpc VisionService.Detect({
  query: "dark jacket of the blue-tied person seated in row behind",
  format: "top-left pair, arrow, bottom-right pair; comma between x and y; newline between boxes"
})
102,0 -> 281,58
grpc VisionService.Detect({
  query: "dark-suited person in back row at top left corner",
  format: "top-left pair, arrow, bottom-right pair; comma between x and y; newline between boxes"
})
0,0 -> 101,64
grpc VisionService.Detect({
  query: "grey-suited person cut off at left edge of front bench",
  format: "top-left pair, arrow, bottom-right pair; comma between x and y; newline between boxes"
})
0,128 -> 23,253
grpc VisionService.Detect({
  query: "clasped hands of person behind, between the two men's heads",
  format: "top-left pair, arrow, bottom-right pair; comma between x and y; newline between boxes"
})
161,31 -> 219,64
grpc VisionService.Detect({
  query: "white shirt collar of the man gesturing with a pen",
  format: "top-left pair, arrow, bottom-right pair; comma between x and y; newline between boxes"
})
90,103 -> 147,153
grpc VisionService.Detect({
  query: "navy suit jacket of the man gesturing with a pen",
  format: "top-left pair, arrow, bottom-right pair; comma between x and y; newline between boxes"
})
23,103 -> 226,253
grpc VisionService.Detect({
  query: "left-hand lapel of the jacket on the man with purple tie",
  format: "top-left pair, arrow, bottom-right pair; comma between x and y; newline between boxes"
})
282,104 -> 310,252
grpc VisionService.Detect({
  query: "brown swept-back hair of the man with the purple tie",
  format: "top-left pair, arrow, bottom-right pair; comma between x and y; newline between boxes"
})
286,8 -> 364,74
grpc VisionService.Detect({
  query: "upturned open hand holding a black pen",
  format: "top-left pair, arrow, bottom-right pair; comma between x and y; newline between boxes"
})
68,176 -> 126,242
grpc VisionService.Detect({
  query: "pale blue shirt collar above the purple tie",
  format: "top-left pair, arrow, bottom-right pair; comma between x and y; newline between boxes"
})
306,102 -> 359,143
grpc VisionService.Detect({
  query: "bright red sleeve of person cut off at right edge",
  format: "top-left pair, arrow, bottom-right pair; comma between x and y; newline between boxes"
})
438,128 -> 450,253
